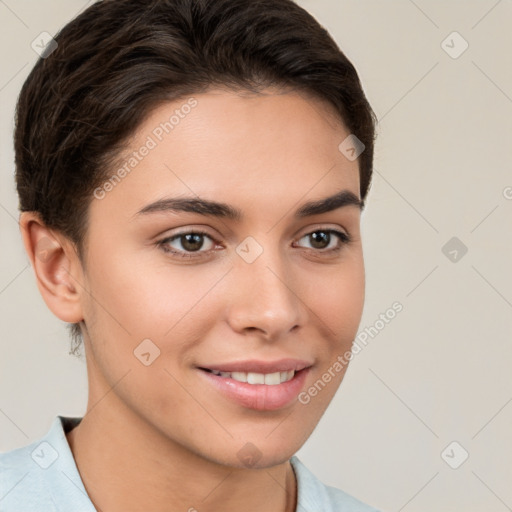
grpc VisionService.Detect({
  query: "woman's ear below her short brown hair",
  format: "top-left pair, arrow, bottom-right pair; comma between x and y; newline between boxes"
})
19,212 -> 84,323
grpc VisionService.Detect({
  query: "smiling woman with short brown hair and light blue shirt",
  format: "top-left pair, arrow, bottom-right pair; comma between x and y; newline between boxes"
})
0,0 -> 380,512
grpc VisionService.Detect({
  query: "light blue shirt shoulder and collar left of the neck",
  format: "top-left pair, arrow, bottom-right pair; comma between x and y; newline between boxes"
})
0,416 -> 94,512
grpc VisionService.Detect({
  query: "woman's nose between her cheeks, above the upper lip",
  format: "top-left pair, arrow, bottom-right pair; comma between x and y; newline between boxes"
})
227,246 -> 308,341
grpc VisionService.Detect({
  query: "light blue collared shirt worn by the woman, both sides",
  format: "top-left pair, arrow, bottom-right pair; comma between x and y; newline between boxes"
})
0,416 -> 377,512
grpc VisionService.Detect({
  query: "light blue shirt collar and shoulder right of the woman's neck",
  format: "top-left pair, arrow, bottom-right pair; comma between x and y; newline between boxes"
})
290,456 -> 378,512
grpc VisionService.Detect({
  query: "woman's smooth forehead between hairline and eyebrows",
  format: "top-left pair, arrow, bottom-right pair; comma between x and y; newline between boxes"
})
89,89 -> 359,223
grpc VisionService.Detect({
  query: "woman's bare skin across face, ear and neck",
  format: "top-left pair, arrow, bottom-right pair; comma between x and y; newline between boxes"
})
20,89 -> 365,512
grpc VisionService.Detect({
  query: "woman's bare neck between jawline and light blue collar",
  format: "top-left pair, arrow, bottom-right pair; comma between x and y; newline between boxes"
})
67,393 -> 297,512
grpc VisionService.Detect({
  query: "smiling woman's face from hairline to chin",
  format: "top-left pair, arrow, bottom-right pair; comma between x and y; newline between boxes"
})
76,89 -> 364,467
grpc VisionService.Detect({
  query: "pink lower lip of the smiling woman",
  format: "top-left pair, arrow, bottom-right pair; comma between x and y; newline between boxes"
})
199,368 -> 309,411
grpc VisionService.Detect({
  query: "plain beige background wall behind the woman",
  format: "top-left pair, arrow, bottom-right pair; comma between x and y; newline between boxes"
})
0,0 -> 512,512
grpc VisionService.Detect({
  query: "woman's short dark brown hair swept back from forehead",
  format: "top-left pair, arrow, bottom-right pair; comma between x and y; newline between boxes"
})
14,0 -> 376,353
